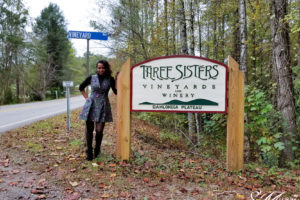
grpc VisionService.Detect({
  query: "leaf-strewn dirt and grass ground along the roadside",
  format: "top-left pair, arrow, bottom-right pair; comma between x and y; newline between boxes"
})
0,97 -> 300,200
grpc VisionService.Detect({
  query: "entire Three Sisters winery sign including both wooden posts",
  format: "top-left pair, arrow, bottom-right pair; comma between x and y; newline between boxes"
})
116,55 -> 244,171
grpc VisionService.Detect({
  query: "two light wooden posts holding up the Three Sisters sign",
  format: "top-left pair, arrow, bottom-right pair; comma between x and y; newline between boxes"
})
116,56 -> 244,171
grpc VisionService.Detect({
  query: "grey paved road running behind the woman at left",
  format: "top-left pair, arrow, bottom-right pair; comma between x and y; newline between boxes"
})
0,96 -> 85,134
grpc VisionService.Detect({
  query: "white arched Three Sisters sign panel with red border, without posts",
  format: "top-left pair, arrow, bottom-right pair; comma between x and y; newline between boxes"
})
131,56 -> 228,113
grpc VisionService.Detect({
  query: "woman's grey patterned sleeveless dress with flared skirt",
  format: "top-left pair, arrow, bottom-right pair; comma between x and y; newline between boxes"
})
80,74 -> 113,122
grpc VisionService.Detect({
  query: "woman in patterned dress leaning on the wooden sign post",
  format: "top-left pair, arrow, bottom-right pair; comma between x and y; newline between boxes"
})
79,60 -> 117,160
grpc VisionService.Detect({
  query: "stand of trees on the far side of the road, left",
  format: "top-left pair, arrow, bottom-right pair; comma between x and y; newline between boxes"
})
0,0 -> 108,105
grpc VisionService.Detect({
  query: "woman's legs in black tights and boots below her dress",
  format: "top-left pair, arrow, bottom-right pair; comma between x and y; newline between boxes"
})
85,121 -> 105,159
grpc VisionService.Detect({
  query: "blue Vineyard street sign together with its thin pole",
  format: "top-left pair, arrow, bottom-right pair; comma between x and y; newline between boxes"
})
68,31 -> 108,94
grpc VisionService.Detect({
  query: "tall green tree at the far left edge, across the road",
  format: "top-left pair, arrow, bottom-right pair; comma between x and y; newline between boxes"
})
0,0 -> 28,104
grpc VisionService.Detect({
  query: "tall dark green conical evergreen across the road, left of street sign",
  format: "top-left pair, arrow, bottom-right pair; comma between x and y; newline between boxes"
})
34,3 -> 71,87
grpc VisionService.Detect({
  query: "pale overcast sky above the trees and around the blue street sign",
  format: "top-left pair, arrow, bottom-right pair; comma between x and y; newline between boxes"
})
24,0 -> 108,56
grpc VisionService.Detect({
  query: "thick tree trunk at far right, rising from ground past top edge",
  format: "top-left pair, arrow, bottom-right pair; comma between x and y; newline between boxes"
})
270,0 -> 297,164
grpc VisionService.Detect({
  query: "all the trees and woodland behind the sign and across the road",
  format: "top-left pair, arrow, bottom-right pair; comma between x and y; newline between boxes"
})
0,0 -> 300,167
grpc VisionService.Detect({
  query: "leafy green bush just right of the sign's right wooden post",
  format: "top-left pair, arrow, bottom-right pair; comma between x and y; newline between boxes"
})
245,85 -> 284,166
